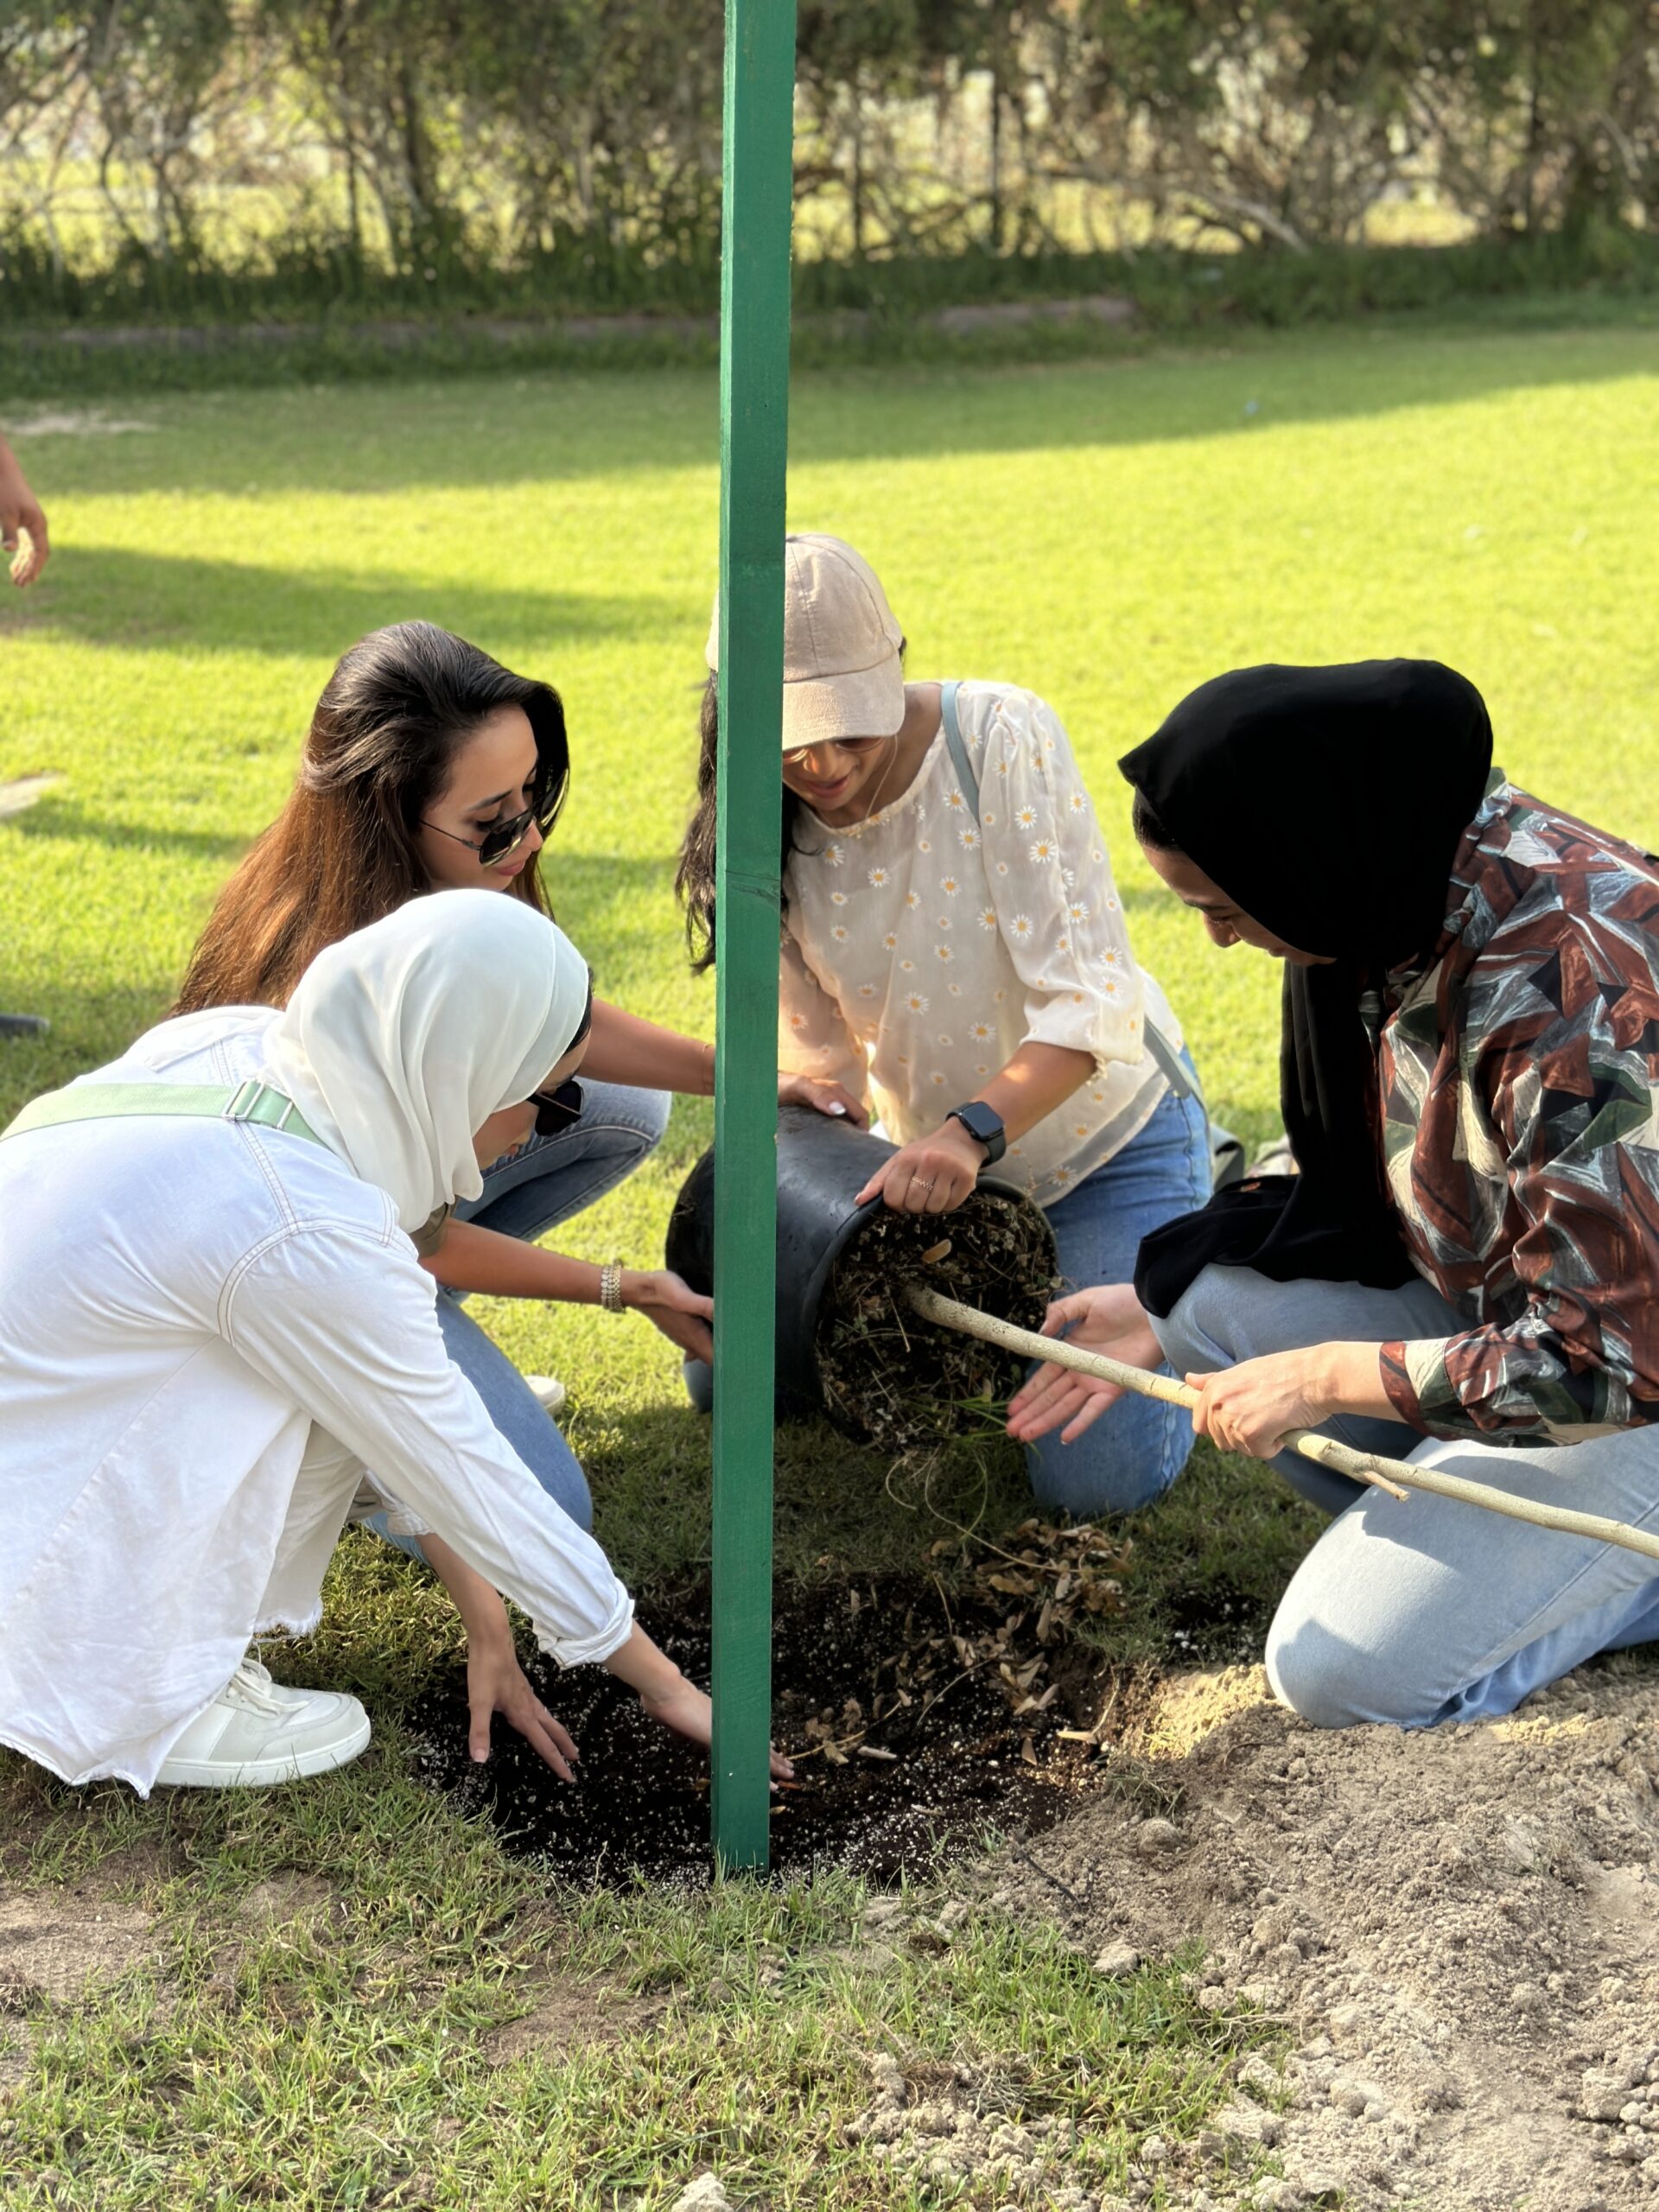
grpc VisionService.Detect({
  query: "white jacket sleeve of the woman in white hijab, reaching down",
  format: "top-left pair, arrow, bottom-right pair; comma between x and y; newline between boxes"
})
221,1224 -> 632,1666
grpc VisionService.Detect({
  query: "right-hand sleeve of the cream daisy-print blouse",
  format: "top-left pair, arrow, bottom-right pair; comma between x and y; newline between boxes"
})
978,690 -> 1146,1071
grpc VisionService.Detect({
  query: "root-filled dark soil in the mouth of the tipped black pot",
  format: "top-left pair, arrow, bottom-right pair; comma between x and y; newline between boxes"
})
817,1188 -> 1055,1453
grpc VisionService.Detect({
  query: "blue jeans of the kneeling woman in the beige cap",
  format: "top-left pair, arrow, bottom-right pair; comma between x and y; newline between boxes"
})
1027,1071 -> 1210,1517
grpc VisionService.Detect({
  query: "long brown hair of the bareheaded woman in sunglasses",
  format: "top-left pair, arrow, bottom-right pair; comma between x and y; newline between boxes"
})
173,621 -> 570,1013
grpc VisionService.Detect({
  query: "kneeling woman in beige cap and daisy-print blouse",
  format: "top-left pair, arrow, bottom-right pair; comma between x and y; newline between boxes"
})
679,533 -> 1210,1513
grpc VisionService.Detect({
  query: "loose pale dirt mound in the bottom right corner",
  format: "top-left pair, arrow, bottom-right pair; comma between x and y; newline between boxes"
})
993,1659 -> 1659,2212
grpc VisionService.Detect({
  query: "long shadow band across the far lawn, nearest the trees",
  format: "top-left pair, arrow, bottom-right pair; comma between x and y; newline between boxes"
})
13,312 -> 1652,499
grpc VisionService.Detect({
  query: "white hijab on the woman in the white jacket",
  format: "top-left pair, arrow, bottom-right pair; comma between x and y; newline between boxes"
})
268,892 -> 588,1232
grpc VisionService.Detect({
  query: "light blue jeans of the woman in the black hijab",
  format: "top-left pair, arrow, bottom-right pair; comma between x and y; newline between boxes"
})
1159,1268 -> 1659,1727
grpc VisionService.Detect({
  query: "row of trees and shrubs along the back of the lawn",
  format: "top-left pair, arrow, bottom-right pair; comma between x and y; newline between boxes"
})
0,0 -> 1659,309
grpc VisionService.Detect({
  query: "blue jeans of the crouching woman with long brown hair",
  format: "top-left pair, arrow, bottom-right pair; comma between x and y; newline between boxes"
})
367,1082 -> 671,1560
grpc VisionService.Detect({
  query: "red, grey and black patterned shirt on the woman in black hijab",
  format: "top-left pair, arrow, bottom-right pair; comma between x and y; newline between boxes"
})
1378,770 -> 1659,1445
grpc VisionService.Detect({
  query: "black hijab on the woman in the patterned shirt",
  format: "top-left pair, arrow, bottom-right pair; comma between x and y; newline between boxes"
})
1117,661 -> 1491,1316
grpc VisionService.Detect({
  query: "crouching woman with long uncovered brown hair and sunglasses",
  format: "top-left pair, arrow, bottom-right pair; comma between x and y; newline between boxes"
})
173,621 -> 856,1548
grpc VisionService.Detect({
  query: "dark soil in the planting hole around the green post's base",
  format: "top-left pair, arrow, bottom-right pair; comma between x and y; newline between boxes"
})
410,1566 -> 1110,1885
